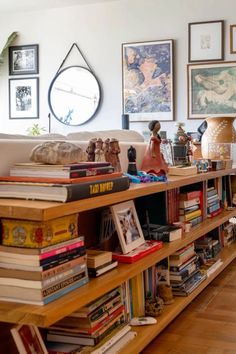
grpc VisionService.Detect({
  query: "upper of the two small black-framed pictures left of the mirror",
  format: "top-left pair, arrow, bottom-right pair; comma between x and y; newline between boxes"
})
9,44 -> 39,75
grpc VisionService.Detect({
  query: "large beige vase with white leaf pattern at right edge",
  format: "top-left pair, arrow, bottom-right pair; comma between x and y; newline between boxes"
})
201,117 -> 236,159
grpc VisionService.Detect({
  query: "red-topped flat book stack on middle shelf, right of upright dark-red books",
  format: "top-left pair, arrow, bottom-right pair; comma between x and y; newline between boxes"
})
179,190 -> 202,226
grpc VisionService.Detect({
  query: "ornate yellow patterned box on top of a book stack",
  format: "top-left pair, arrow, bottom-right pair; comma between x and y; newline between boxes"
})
2,214 -> 78,248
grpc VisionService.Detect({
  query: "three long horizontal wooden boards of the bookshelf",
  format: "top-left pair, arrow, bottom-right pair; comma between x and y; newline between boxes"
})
0,169 -> 236,354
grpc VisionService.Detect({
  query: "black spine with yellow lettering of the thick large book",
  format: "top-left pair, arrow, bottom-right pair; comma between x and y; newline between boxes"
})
65,176 -> 130,202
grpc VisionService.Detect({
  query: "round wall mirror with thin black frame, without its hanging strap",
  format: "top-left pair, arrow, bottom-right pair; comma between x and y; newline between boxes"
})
48,66 -> 101,125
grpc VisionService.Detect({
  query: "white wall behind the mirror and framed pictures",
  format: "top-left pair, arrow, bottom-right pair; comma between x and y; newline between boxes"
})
0,0 -> 236,138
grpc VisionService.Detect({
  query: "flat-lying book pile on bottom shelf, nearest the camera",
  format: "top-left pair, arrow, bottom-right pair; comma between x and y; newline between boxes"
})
46,286 -> 136,353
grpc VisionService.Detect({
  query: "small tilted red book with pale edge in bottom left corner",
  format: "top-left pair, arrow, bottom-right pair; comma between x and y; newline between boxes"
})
11,325 -> 48,354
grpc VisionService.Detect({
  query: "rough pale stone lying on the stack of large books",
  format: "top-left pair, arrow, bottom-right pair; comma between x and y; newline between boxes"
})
30,141 -> 83,165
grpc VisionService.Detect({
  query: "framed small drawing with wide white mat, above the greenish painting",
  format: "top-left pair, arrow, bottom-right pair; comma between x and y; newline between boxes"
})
188,20 -> 224,62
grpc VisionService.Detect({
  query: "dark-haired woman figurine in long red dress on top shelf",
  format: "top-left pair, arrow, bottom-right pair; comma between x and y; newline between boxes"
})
141,120 -> 168,175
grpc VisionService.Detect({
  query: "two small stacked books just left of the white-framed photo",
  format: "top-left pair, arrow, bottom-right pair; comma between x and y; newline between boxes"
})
87,249 -> 118,278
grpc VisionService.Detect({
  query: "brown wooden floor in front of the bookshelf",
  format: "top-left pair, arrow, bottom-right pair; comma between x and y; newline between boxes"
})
142,260 -> 236,354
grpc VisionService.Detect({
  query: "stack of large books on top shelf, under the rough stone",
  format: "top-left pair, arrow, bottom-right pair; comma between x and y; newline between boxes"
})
0,162 -> 129,202
